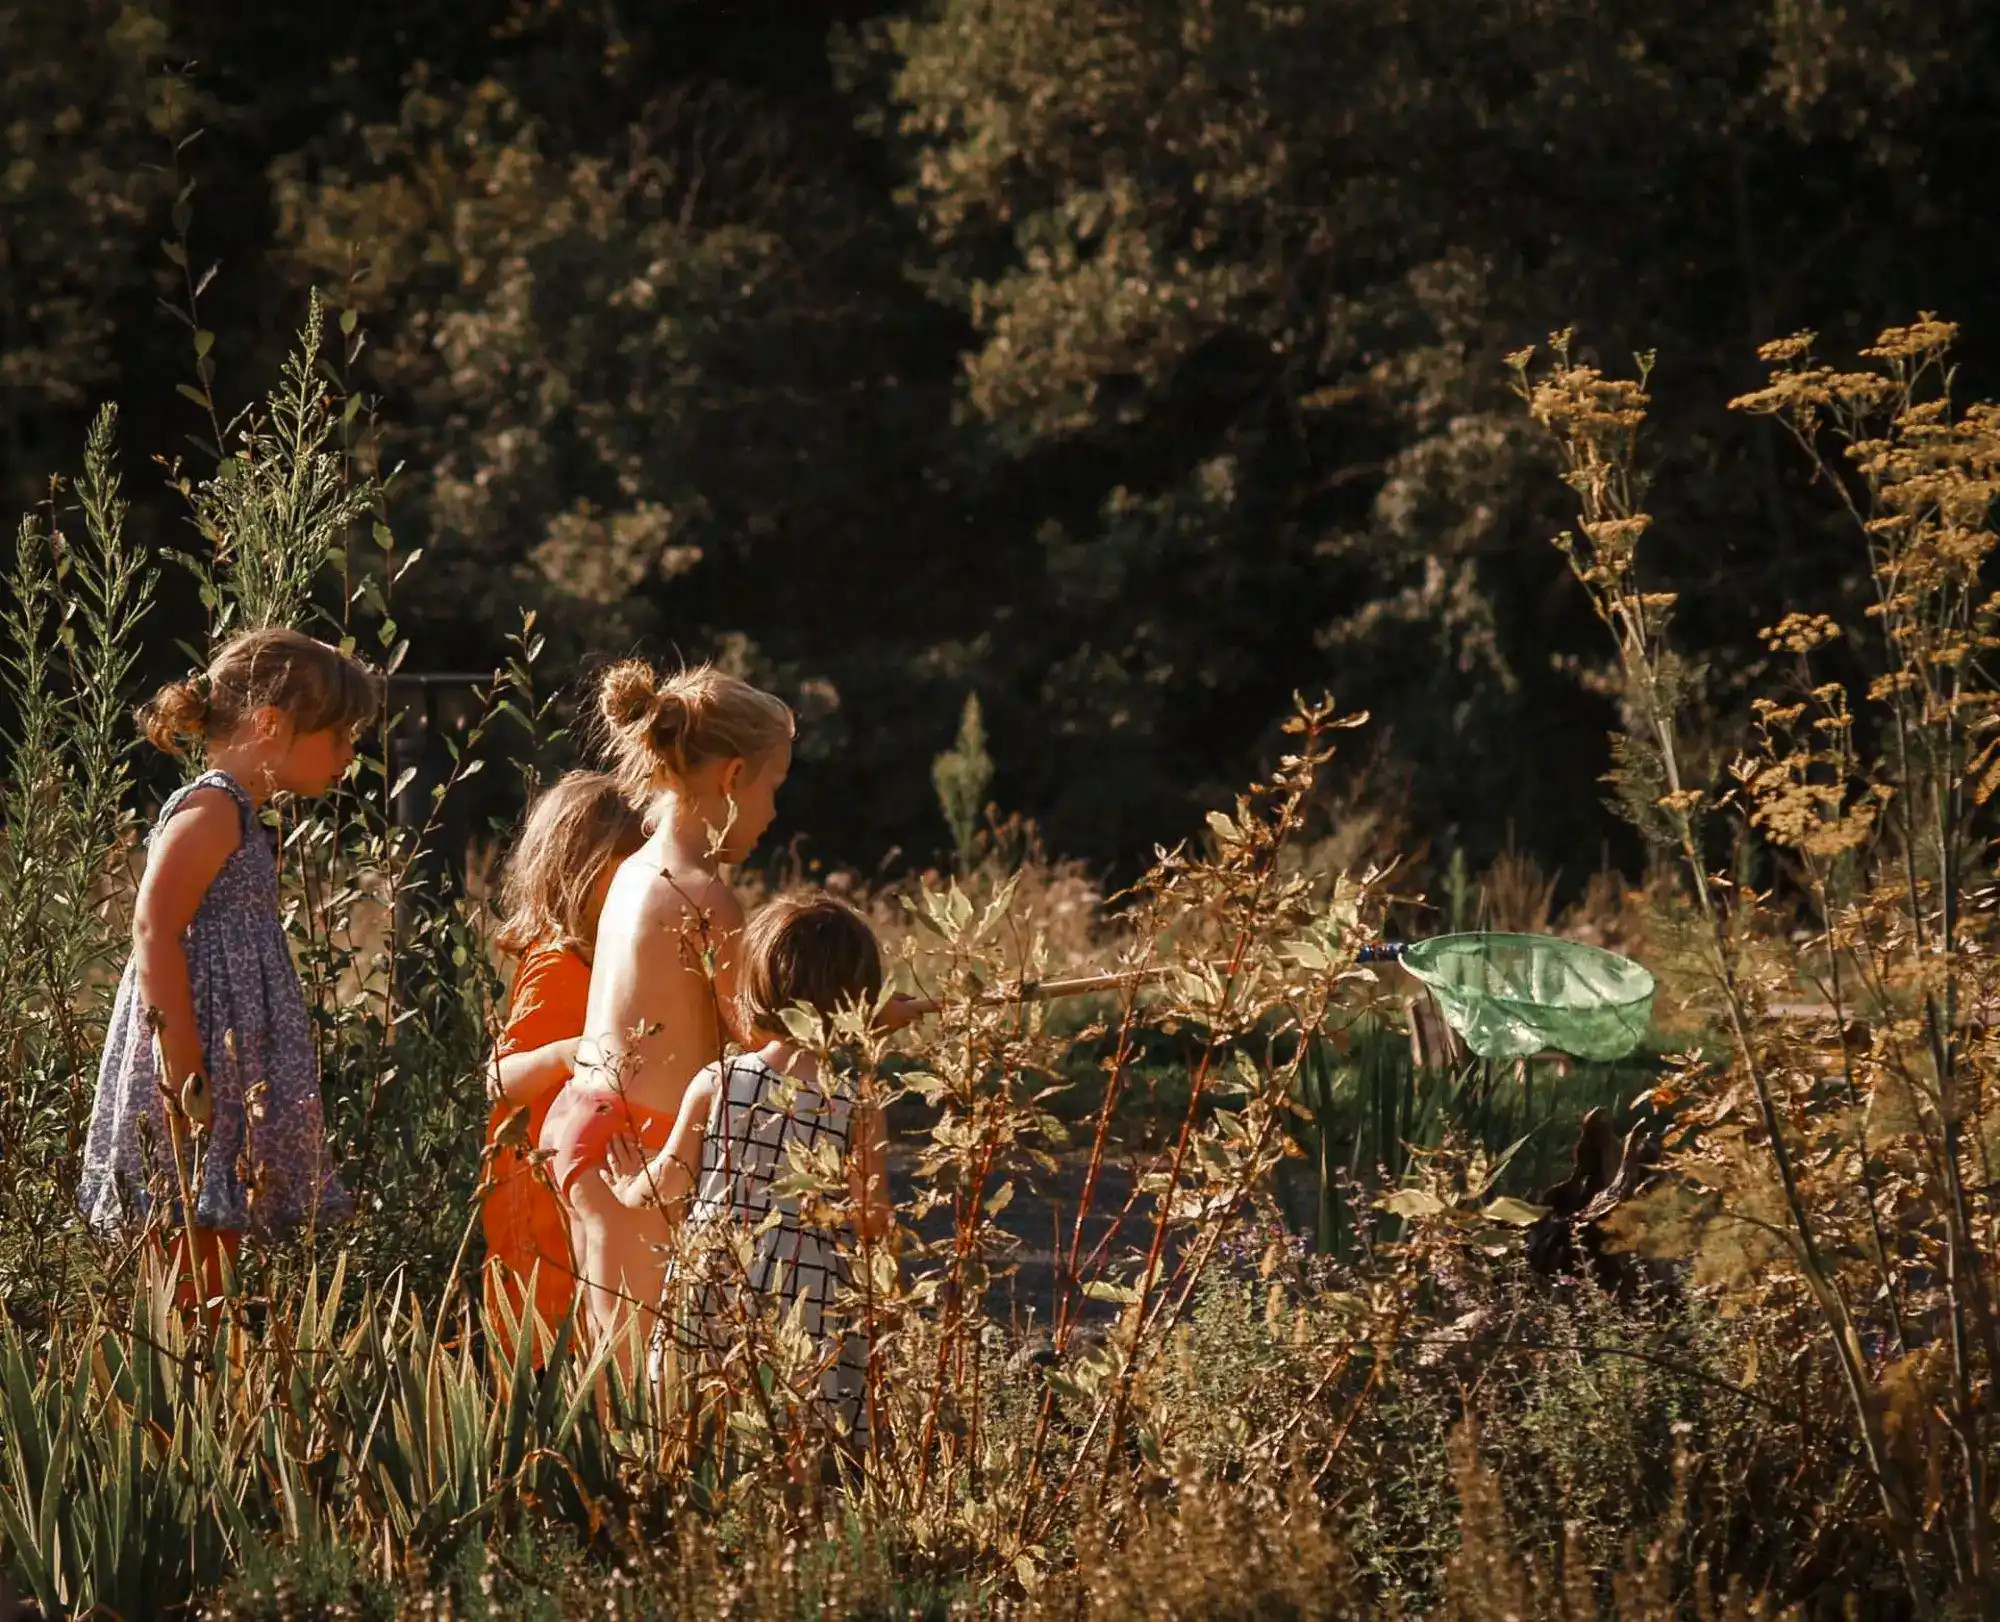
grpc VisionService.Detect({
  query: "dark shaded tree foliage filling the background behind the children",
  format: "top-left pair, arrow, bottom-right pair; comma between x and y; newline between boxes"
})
0,0 -> 2000,878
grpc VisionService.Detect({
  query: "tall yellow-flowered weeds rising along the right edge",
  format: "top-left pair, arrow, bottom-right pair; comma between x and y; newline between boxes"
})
1516,316 -> 2000,1614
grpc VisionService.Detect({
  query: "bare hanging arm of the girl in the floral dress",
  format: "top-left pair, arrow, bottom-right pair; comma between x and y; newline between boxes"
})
132,788 -> 244,1092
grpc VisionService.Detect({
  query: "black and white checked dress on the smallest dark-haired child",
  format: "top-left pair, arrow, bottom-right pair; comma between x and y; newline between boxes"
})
656,1054 -> 868,1436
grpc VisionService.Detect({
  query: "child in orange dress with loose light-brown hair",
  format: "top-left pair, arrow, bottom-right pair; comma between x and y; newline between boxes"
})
480,772 -> 644,1364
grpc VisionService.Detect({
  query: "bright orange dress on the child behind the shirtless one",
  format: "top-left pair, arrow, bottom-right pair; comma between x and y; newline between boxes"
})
480,942 -> 590,1362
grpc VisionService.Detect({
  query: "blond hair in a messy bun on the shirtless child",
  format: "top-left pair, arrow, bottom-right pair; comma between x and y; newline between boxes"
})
598,658 -> 796,800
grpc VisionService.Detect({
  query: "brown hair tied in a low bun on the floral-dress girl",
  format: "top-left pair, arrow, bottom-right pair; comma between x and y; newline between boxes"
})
138,626 -> 382,754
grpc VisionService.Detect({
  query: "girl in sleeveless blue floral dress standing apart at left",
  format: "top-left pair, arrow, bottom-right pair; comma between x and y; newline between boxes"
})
78,630 -> 382,1302
